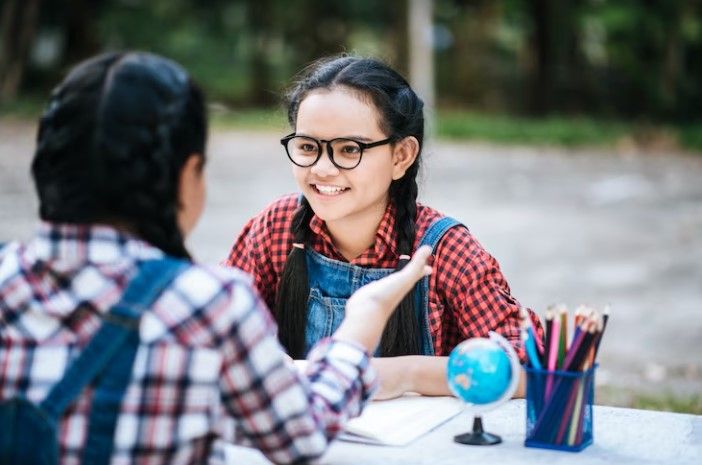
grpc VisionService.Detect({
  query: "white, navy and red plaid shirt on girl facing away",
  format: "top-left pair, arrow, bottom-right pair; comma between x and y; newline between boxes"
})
0,223 -> 375,465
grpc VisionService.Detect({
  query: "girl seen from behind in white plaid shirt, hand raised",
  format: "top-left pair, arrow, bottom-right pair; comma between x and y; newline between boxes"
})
0,52 -> 431,465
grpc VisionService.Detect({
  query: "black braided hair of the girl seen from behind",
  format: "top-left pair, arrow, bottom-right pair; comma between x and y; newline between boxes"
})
32,52 -> 207,258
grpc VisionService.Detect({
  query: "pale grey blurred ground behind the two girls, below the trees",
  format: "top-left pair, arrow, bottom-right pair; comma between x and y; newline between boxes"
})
0,120 -> 702,405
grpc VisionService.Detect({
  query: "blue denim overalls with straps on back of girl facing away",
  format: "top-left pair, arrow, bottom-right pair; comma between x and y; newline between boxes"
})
0,258 -> 188,465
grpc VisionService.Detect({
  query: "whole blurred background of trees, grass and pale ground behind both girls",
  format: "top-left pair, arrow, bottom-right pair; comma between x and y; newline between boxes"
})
0,0 -> 702,413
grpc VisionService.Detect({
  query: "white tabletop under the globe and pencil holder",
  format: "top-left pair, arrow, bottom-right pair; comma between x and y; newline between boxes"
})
226,400 -> 702,465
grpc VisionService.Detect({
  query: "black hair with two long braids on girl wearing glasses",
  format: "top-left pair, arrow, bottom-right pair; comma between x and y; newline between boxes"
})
275,56 -> 424,357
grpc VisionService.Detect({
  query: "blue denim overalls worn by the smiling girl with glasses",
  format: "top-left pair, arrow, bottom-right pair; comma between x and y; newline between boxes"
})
305,217 -> 460,355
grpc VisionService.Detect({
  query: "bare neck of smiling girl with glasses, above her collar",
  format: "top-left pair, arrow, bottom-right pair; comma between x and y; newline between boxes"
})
326,199 -> 388,261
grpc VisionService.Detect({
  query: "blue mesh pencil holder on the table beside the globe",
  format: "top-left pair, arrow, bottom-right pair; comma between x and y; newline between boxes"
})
524,365 -> 597,452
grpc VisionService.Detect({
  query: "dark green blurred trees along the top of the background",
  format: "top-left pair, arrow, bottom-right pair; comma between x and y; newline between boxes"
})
0,0 -> 702,122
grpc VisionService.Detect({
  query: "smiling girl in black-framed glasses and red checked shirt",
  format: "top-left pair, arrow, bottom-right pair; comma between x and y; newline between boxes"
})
225,56 -> 541,397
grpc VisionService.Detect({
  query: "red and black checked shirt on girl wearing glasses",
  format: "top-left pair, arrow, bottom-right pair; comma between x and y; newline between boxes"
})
225,194 -> 543,361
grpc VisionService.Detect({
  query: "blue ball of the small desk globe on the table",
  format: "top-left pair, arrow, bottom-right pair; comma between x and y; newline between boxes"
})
447,338 -> 512,405
